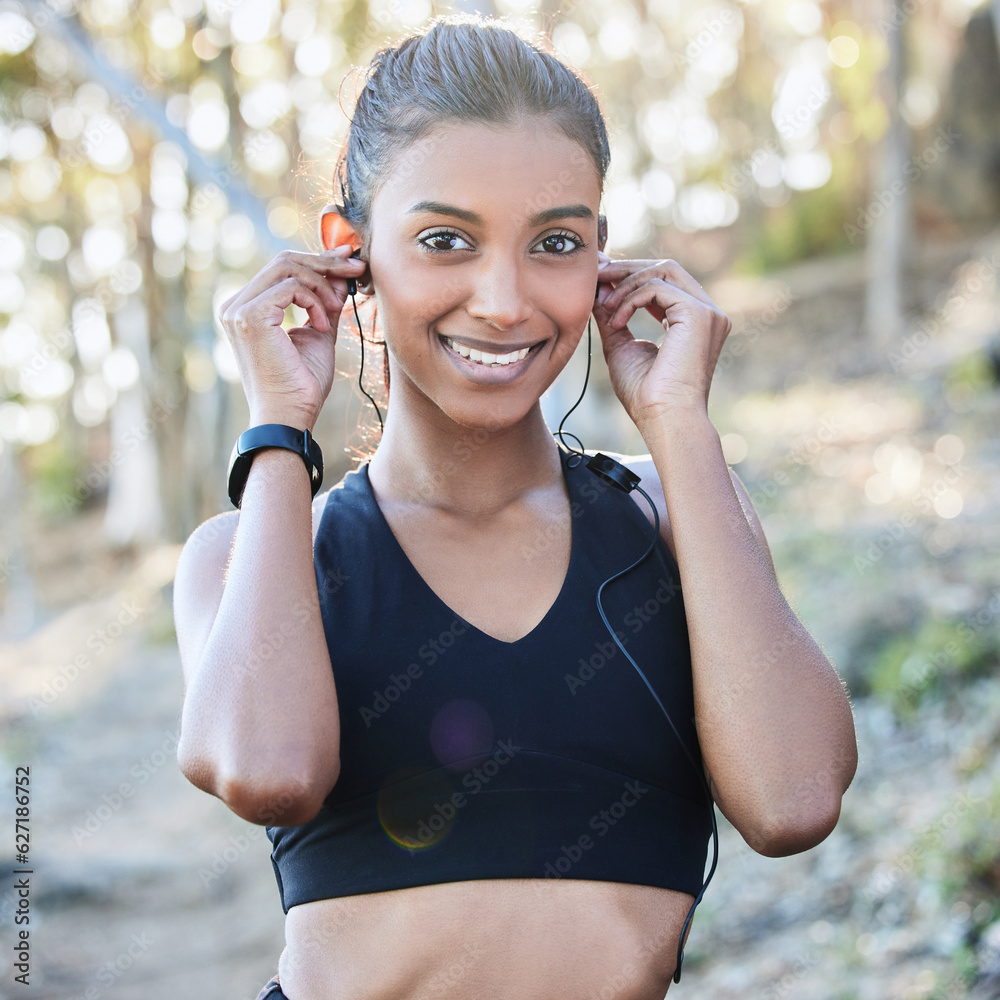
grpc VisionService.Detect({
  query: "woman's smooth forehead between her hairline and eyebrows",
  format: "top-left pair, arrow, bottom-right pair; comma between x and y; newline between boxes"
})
372,119 -> 601,226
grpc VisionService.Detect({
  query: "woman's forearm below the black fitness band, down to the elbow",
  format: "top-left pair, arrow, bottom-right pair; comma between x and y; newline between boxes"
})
181,449 -> 340,825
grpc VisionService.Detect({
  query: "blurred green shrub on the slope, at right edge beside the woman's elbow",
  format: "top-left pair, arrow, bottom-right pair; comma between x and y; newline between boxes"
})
868,621 -> 1000,718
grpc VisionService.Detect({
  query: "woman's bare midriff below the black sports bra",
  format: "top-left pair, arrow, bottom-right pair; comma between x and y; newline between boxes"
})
278,879 -> 692,1000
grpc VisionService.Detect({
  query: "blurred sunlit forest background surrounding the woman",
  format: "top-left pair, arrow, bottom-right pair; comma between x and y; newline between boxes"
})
0,0 -> 1000,1000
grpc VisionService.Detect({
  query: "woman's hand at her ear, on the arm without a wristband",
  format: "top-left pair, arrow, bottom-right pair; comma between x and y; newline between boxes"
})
594,253 -> 733,430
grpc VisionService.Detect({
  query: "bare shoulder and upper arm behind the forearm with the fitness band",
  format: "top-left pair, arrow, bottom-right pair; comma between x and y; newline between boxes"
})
173,490 -> 330,680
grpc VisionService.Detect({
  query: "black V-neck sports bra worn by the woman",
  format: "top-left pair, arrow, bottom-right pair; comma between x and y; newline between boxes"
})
267,447 -> 711,913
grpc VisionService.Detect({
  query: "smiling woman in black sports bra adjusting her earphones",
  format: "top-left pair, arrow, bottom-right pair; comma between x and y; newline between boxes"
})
175,18 -> 857,1000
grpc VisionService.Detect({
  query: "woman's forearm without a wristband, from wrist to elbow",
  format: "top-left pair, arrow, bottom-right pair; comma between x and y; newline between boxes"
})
643,411 -> 857,853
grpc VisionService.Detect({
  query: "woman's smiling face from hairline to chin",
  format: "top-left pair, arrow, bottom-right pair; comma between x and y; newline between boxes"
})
368,119 -> 601,429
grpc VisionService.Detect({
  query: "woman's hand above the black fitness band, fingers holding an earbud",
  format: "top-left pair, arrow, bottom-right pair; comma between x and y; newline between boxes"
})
219,245 -> 366,431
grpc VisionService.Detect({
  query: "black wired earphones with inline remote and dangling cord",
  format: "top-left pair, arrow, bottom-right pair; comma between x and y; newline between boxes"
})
347,260 -> 719,983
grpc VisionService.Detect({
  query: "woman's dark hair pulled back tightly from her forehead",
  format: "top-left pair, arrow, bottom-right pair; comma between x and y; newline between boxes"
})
334,14 -> 611,438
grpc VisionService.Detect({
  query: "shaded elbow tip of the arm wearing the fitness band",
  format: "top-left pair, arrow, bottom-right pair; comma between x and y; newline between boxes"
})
177,736 -> 340,826
